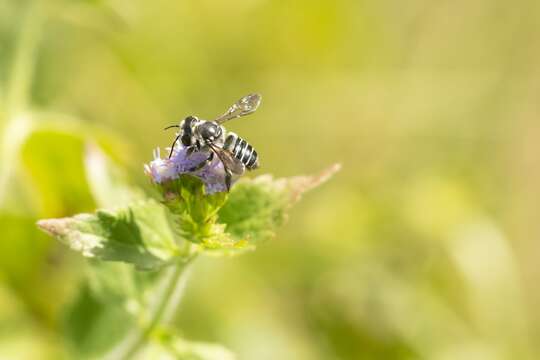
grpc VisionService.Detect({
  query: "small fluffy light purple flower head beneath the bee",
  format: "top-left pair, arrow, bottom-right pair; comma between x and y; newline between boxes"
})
144,142 -> 238,194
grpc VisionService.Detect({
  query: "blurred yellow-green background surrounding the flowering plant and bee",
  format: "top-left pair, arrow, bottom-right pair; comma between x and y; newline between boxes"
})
0,0 -> 540,359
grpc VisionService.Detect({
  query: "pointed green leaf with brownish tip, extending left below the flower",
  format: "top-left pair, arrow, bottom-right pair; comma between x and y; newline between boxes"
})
38,200 -> 187,270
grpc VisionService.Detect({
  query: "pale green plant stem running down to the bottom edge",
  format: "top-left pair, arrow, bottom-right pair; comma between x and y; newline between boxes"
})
104,257 -> 194,360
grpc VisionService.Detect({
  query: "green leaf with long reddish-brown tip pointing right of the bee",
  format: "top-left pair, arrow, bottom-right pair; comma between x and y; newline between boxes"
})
219,164 -> 340,244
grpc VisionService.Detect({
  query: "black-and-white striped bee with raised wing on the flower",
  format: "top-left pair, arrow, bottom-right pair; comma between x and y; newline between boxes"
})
165,94 -> 261,191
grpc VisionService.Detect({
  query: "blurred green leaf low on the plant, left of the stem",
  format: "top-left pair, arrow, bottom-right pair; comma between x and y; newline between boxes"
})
63,260 -> 170,359
